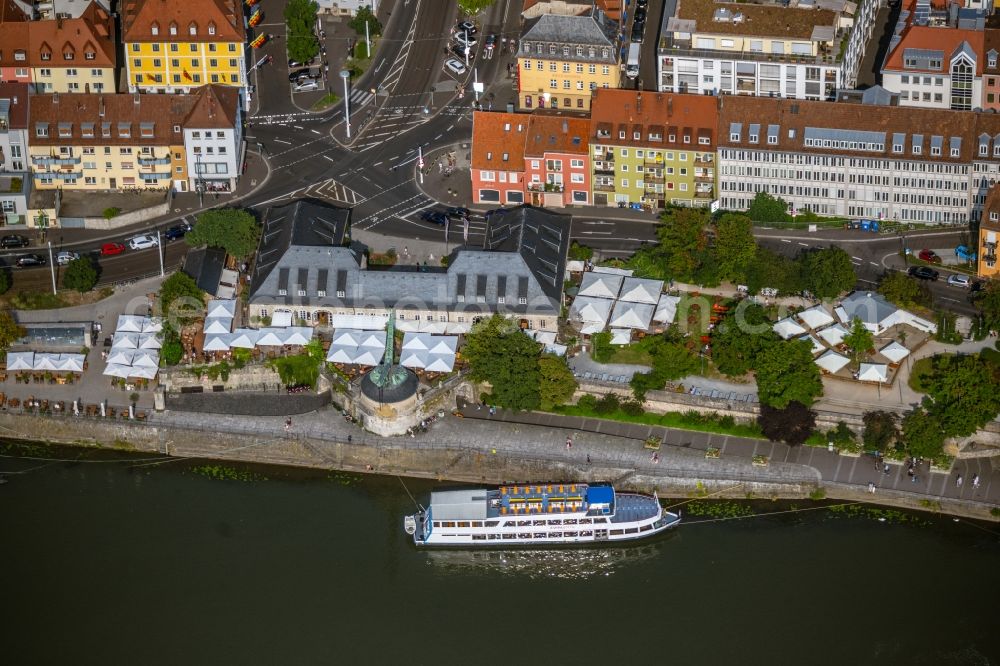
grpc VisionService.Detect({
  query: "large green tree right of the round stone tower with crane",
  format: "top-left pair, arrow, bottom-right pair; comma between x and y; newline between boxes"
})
463,314 -> 542,410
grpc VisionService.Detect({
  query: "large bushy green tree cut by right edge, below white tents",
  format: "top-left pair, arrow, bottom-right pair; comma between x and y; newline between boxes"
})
923,354 -> 1000,437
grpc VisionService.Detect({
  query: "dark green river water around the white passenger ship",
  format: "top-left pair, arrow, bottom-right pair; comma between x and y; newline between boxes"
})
0,451 -> 1000,666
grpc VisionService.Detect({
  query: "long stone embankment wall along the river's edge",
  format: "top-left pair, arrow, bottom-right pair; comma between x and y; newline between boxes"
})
0,413 -> 992,520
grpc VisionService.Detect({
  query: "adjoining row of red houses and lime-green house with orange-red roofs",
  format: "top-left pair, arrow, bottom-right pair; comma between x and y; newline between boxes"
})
471,89 -> 717,208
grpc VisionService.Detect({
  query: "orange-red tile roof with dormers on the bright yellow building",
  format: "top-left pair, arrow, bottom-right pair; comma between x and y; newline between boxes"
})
122,0 -> 245,42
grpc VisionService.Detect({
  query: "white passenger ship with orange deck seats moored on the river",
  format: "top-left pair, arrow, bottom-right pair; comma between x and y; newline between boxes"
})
404,483 -> 681,548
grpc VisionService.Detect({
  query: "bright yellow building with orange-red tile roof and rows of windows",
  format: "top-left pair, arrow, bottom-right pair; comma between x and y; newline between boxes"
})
122,0 -> 246,93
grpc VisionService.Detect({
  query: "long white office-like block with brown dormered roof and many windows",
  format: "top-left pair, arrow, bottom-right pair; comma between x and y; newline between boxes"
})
717,97 -> 1000,224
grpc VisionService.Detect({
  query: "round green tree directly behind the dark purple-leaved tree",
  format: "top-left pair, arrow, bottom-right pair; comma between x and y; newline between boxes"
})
754,340 -> 823,409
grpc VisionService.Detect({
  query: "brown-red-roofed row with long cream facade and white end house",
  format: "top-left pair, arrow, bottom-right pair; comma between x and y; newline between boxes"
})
0,83 -> 244,224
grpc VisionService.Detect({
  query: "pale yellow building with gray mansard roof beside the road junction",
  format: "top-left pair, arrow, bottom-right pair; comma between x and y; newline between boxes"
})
517,9 -> 621,111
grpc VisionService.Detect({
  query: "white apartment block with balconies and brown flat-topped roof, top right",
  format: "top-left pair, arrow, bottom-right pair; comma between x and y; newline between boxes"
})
657,0 -> 880,100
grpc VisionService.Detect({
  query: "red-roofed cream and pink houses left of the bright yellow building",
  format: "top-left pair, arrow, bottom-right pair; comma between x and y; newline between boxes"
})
0,0 -> 118,93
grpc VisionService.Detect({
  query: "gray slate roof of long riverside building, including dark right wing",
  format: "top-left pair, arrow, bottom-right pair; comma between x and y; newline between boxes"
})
250,207 -> 570,315
